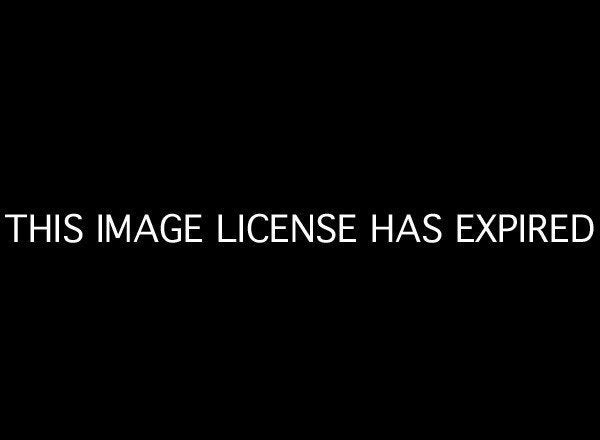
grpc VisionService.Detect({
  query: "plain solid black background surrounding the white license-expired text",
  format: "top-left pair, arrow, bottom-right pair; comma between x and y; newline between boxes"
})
1,5 -> 598,433
